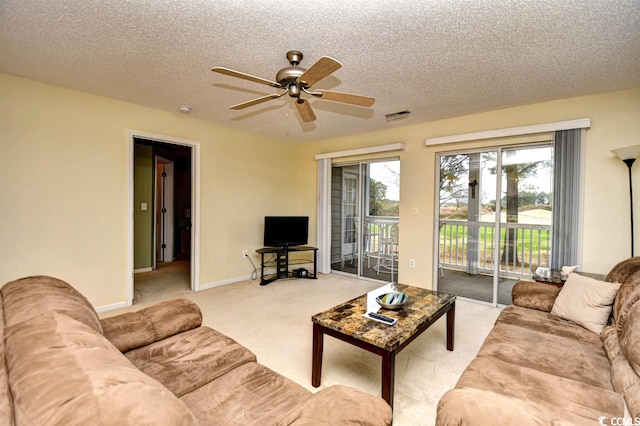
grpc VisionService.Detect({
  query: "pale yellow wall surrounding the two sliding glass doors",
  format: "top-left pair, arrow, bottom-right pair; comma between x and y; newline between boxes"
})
300,89 -> 640,288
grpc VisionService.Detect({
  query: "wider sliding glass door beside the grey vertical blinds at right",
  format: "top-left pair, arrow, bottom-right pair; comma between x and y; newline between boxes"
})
435,144 -> 553,304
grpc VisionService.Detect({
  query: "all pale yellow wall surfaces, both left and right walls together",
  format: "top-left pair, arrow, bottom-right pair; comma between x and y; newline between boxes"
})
0,74 -> 640,306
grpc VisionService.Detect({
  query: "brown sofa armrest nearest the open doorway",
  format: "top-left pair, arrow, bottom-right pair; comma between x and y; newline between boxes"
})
100,299 -> 202,352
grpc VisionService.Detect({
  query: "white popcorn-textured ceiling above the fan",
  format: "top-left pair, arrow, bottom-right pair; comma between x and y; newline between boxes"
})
0,0 -> 640,142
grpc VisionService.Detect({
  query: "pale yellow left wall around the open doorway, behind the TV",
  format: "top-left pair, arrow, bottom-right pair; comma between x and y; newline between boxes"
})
0,74 -> 299,306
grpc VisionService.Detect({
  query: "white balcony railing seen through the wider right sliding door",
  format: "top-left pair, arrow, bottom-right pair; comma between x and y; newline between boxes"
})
439,220 -> 551,278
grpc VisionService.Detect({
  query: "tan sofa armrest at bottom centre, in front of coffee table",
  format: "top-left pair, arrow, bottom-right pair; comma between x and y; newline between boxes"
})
276,385 -> 393,426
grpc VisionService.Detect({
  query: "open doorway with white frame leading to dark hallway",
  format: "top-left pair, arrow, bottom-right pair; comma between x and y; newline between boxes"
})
127,131 -> 199,305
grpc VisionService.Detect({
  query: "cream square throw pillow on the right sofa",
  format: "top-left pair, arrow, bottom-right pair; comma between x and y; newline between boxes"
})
551,273 -> 620,334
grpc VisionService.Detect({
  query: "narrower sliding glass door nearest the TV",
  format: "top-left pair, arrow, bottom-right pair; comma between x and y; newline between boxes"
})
331,160 -> 400,282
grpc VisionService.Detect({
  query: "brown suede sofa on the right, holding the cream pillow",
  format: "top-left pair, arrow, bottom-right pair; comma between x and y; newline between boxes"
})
436,257 -> 640,426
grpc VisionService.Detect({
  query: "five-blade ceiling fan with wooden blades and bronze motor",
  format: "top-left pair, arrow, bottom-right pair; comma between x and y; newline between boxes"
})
211,50 -> 375,122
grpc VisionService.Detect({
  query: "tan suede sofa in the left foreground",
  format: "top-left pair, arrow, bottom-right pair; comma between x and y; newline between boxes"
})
0,276 -> 391,426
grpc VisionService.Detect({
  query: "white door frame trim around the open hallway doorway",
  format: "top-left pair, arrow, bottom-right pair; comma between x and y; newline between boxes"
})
126,129 -> 200,306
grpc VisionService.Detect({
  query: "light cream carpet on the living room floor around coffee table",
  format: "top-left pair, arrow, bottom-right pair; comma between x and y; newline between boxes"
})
107,264 -> 500,426
